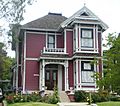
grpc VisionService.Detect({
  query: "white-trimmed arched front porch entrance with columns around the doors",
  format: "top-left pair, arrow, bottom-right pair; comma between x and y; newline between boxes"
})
39,59 -> 69,91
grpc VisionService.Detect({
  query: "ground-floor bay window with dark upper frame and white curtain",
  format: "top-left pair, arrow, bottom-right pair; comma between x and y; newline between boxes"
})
81,61 -> 94,83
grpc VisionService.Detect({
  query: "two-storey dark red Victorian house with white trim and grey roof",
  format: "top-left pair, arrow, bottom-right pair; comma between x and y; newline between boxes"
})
13,6 -> 108,93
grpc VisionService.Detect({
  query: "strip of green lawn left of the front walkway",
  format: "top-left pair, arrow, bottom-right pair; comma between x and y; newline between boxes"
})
8,102 -> 57,106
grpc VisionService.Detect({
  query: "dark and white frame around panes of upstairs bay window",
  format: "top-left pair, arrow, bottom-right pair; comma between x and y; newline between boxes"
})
81,28 -> 94,48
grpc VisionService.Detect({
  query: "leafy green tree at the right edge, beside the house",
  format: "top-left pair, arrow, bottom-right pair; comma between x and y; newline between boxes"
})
99,33 -> 120,91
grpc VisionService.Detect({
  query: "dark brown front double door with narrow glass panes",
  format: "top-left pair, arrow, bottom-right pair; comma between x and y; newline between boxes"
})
45,70 -> 58,90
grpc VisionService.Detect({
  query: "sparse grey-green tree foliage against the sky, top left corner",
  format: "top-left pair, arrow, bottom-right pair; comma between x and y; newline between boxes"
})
0,0 -> 34,23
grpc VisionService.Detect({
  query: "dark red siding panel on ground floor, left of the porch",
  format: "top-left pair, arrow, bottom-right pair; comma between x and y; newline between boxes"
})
25,60 -> 39,90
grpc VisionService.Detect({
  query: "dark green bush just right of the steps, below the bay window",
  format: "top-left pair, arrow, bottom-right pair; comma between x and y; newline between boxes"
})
75,91 -> 88,102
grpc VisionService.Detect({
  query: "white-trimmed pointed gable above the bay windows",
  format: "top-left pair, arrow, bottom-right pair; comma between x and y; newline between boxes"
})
60,6 -> 108,30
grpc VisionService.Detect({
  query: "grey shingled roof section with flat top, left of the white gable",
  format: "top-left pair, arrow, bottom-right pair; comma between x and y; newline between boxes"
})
22,13 -> 67,29
